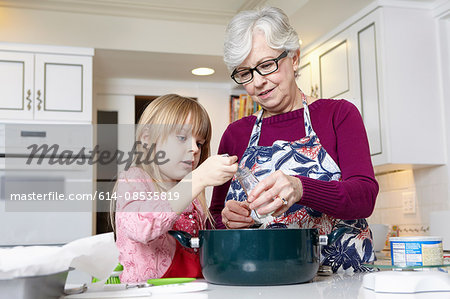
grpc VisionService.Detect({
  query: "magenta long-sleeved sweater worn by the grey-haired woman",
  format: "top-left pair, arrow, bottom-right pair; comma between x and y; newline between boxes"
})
210,99 -> 378,228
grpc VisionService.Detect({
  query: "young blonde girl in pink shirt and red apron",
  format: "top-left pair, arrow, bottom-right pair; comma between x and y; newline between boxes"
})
115,94 -> 237,282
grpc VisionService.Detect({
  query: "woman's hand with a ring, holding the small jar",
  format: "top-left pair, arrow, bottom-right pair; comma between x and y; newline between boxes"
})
247,170 -> 303,217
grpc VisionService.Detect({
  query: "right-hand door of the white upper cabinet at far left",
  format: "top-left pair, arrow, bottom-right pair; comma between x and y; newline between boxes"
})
34,54 -> 92,121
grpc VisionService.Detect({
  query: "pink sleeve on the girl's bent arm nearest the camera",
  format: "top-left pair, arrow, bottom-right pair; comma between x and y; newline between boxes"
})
116,168 -> 179,244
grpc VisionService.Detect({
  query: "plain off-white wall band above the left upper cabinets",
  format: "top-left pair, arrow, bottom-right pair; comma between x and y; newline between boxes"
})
0,7 -> 225,55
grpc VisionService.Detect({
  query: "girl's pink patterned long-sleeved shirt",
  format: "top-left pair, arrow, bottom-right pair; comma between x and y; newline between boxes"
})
115,167 -> 206,282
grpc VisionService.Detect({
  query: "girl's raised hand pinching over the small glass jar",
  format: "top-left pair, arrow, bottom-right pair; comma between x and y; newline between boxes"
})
192,155 -> 238,188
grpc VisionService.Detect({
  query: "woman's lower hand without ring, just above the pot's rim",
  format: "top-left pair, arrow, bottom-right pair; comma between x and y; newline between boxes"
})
222,200 -> 254,228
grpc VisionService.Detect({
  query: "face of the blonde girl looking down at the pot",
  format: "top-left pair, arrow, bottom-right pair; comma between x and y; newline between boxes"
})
156,116 -> 205,182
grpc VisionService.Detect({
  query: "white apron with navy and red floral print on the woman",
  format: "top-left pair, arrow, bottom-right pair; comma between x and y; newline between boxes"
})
225,93 -> 375,272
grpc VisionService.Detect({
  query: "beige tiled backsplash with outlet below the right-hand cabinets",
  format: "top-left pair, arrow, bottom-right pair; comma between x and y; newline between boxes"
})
368,166 -> 450,236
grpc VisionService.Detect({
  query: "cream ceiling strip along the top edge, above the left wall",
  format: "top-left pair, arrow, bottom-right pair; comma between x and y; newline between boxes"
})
0,0 -> 308,24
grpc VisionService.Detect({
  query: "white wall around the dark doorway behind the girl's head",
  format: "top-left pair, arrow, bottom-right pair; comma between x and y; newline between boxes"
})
93,79 -> 236,204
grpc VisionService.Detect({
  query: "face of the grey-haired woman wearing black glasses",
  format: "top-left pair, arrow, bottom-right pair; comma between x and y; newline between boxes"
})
238,31 -> 299,114
